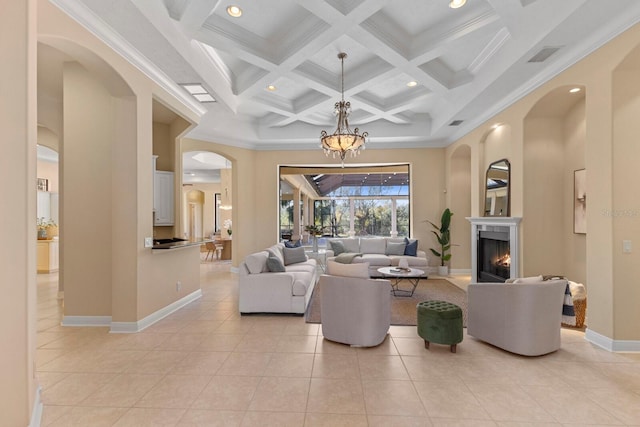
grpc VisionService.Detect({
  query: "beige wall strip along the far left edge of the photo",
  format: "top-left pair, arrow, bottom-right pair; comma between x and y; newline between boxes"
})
0,0 -> 37,426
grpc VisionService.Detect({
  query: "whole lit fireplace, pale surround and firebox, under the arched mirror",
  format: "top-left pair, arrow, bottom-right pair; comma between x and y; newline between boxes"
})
467,217 -> 522,283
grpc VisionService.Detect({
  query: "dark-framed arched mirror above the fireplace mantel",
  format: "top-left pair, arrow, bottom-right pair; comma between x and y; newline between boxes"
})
484,159 -> 511,216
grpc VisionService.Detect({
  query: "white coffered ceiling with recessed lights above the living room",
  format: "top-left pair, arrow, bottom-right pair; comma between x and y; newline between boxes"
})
51,0 -> 640,150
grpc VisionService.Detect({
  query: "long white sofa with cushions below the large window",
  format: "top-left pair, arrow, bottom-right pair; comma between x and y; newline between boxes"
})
327,237 -> 429,277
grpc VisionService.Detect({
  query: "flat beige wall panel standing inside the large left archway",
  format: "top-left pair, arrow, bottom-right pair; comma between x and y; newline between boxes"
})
60,62 -> 117,316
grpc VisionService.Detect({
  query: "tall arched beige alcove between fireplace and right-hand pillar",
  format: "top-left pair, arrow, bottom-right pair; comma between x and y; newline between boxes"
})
522,85 -> 586,283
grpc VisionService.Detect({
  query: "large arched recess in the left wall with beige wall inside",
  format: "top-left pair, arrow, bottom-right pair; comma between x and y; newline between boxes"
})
38,36 -> 137,321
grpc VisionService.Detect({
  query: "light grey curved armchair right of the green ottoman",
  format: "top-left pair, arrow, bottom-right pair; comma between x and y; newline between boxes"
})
467,280 -> 567,356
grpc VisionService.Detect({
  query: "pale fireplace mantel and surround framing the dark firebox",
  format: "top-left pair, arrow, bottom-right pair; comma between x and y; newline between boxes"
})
467,216 -> 522,283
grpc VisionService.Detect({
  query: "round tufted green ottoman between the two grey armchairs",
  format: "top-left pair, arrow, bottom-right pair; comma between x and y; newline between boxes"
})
416,300 -> 462,353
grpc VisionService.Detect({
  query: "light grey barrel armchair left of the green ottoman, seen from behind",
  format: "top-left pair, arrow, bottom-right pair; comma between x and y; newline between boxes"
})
318,275 -> 391,347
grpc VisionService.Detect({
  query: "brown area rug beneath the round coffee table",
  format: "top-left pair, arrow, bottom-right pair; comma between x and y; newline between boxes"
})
306,279 -> 467,326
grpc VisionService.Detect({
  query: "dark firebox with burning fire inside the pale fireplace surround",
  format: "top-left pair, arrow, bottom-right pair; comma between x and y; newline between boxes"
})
477,231 -> 511,282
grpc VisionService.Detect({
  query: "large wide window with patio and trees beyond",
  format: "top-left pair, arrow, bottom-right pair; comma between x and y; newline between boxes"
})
280,164 -> 411,239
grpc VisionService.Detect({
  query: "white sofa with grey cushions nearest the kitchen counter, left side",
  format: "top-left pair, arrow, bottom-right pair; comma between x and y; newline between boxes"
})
238,243 -> 318,314
